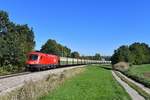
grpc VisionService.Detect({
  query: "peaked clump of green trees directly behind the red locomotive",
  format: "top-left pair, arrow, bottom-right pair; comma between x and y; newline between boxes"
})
40,39 -> 71,57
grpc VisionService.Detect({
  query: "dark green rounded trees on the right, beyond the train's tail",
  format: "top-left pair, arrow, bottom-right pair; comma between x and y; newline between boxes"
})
111,42 -> 150,65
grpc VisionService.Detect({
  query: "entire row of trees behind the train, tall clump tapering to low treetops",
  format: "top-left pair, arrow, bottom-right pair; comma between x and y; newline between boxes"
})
40,39 -> 101,60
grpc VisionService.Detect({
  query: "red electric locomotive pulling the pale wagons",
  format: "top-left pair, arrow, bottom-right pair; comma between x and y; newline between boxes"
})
26,52 -> 60,70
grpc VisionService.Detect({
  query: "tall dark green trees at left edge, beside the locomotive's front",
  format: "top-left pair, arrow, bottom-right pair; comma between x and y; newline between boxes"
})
0,11 -> 35,71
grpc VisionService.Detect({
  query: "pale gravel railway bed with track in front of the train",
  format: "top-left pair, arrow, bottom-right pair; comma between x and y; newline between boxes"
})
0,65 -> 85,95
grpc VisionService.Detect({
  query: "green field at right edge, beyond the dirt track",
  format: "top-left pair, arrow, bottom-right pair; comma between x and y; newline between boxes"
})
124,64 -> 150,87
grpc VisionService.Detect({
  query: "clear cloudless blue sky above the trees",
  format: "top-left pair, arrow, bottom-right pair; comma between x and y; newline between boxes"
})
0,0 -> 150,55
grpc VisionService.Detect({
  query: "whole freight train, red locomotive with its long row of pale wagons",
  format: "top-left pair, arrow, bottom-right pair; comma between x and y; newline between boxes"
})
26,52 -> 111,71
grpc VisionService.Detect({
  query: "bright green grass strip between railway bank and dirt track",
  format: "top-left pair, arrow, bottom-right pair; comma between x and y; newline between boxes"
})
40,66 -> 131,100
